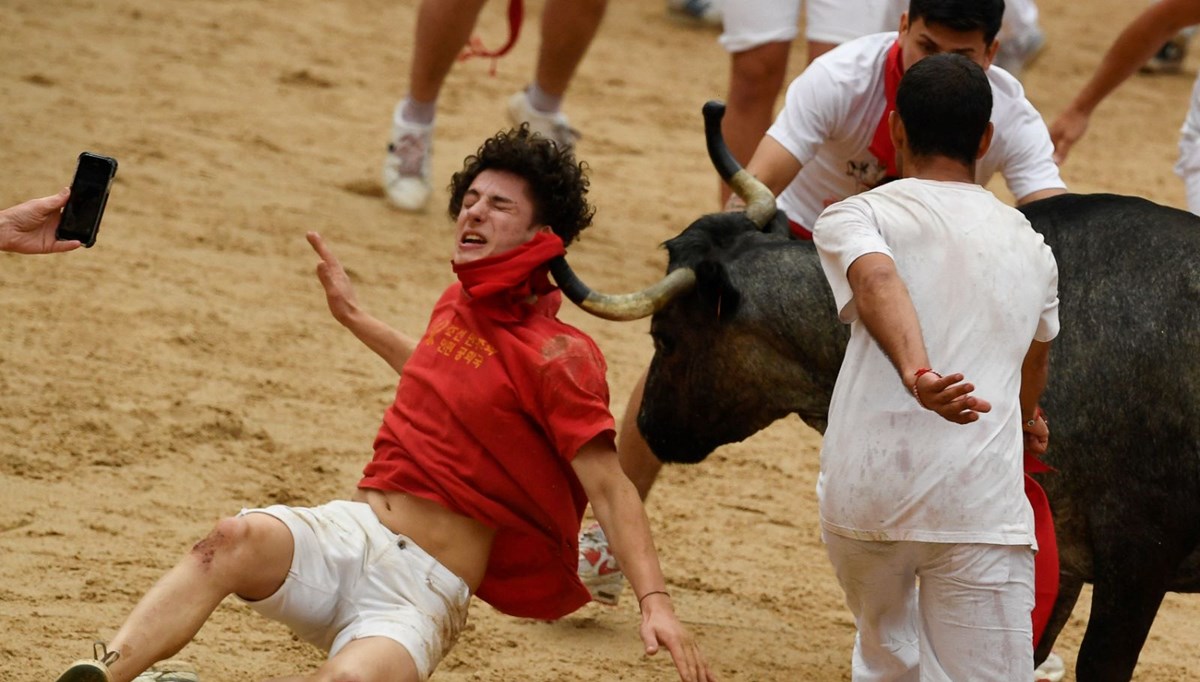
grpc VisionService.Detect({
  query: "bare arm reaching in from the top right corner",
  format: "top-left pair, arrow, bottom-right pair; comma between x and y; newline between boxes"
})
1050,0 -> 1200,163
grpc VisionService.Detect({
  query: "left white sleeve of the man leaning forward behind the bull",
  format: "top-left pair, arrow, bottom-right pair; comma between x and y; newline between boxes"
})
767,60 -> 850,166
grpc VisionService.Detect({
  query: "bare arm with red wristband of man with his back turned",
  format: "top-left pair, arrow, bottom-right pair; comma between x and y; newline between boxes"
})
846,253 -> 991,424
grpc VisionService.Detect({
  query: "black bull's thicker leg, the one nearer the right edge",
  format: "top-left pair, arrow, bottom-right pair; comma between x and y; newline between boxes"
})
1075,545 -> 1174,682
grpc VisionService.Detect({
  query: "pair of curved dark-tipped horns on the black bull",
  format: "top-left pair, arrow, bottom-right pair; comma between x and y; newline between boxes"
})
550,101 -> 776,322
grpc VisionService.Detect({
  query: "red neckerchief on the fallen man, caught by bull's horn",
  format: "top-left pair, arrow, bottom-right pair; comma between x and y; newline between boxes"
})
454,231 -> 566,319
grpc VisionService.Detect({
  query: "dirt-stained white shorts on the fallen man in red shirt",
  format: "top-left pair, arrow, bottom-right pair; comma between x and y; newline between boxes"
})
239,502 -> 470,681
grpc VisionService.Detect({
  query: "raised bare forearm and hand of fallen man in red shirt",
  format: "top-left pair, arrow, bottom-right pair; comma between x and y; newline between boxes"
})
307,232 -> 416,373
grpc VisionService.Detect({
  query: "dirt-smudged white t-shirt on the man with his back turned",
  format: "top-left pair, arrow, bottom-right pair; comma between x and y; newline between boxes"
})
814,179 -> 1058,546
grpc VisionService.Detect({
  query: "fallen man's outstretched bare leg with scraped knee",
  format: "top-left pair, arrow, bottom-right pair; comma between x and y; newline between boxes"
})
100,514 -> 293,682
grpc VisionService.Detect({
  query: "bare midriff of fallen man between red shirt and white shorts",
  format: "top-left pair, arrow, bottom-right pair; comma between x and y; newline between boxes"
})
354,487 -> 496,593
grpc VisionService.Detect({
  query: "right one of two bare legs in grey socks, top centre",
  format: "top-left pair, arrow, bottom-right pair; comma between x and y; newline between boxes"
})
537,0 -> 608,97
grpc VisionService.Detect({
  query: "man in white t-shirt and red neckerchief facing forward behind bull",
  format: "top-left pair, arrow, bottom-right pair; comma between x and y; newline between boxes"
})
746,0 -> 1066,235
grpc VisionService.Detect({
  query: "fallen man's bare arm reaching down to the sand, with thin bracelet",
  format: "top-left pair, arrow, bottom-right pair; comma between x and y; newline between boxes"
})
572,438 -> 715,682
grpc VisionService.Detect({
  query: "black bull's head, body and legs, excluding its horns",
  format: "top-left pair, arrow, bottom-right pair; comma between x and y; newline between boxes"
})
638,195 -> 1200,681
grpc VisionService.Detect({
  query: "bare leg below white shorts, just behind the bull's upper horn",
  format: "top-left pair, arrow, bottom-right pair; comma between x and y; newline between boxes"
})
720,41 -> 792,207
